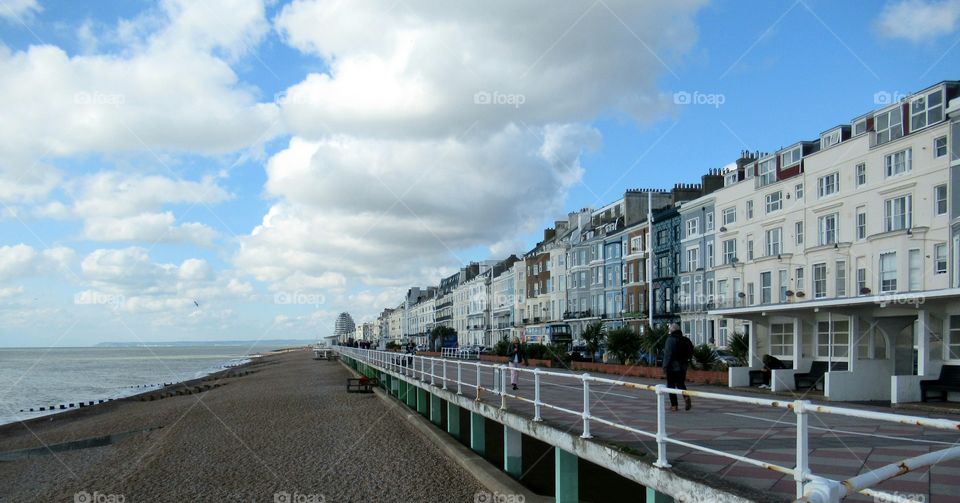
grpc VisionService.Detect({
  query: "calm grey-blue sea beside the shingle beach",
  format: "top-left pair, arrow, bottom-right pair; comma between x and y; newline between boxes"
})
0,344 -> 276,425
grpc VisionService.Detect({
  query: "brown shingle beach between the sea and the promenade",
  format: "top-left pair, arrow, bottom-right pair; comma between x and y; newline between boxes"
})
0,351 -> 482,503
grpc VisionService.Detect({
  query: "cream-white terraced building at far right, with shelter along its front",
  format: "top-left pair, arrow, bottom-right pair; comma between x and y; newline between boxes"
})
710,82 -> 960,402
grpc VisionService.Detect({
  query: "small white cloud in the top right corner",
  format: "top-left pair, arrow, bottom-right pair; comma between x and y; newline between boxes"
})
876,0 -> 960,43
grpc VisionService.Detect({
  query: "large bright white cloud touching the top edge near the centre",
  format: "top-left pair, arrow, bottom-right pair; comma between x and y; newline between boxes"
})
275,0 -> 702,138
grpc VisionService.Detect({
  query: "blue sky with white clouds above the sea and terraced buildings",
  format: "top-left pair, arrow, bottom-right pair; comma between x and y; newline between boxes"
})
0,0 -> 960,347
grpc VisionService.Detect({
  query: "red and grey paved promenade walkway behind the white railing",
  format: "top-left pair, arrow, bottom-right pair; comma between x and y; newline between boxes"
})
382,360 -> 960,503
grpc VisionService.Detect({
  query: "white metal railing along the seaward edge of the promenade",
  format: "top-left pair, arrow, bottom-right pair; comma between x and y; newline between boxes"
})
337,347 -> 960,503
